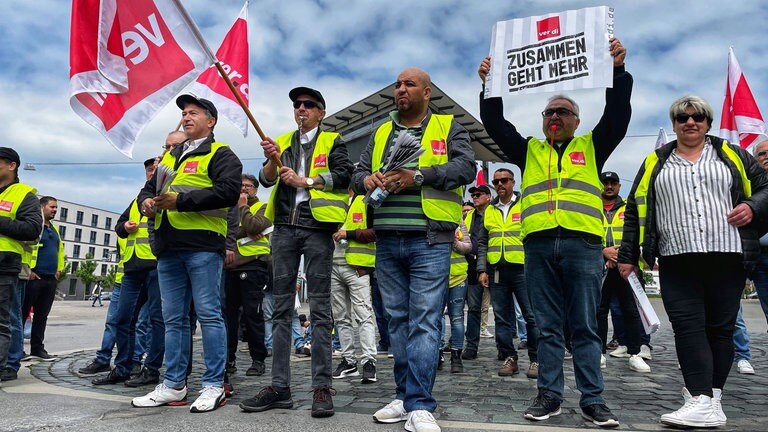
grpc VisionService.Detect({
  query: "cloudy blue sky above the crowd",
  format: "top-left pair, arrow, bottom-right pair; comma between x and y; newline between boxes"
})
0,0 -> 768,212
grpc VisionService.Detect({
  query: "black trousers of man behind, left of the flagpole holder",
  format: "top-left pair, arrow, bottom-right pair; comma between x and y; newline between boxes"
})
224,264 -> 269,362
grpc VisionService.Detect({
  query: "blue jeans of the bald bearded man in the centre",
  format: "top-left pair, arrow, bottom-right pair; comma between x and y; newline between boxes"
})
376,233 -> 451,412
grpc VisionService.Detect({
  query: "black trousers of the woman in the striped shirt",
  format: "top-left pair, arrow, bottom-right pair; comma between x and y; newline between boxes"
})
659,252 -> 747,397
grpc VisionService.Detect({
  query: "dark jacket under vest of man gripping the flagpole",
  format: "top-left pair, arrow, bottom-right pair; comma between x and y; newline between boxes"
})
259,130 -> 352,231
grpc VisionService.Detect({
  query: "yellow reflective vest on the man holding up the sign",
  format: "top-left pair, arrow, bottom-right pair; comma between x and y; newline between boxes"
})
522,132 -> 605,238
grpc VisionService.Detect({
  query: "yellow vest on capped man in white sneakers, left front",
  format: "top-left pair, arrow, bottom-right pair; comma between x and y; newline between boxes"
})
155,142 -> 227,237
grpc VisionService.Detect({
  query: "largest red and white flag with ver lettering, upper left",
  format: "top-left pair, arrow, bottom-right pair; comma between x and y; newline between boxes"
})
69,0 -> 216,157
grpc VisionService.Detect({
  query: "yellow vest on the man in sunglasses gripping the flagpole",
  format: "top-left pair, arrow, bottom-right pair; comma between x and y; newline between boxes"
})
265,131 -> 349,223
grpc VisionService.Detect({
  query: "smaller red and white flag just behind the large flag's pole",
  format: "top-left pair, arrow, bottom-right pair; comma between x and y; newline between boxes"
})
189,1 -> 249,136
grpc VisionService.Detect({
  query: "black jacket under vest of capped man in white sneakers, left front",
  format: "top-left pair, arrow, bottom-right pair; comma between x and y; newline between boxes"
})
137,134 -> 243,257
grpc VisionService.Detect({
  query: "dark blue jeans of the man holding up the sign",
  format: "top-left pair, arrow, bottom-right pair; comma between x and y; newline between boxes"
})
528,236 -> 605,407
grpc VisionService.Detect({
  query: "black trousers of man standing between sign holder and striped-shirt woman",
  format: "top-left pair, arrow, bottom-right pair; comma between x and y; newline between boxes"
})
597,268 -> 644,354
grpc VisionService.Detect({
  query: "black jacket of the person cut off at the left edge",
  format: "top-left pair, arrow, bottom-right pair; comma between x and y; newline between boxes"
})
0,180 -> 43,276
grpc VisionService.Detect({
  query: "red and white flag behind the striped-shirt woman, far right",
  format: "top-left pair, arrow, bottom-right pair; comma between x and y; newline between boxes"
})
720,48 -> 768,149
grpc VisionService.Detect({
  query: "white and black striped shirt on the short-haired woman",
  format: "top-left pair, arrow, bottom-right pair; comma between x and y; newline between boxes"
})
655,139 -> 741,256
